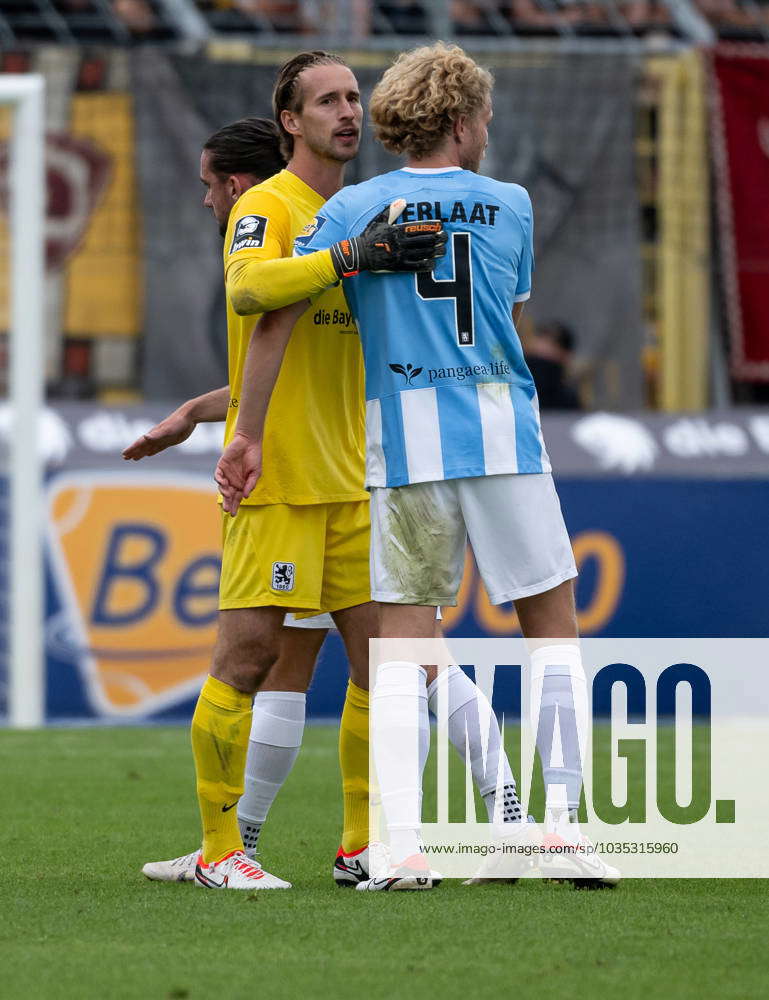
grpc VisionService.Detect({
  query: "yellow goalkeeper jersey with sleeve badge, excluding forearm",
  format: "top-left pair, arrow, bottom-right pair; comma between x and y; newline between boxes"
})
224,170 -> 368,505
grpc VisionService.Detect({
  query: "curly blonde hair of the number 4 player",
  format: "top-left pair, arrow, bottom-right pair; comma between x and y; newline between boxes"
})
369,42 -> 494,159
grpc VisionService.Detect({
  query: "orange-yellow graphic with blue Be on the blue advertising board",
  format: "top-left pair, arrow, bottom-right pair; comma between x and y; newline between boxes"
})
49,472 -> 221,716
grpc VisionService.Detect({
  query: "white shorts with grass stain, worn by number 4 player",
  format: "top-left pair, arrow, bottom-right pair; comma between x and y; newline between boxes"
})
371,472 -> 577,606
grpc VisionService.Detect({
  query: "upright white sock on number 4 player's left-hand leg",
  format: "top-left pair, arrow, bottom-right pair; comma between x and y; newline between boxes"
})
371,660 -> 430,865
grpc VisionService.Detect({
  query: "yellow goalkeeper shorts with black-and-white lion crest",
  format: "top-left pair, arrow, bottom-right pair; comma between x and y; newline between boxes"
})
219,500 -> 371,618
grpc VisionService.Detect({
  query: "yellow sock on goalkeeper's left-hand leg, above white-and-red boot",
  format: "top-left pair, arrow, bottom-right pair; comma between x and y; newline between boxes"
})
192,677 -> 252,864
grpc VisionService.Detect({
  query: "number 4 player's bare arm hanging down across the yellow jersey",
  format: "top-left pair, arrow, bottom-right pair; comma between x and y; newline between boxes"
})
214,299 -> 308,517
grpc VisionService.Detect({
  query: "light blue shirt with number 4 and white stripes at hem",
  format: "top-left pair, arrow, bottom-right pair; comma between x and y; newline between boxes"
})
295,167 -> 550,486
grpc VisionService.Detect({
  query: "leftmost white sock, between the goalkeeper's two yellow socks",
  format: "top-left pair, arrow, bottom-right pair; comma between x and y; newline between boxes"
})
238,691 -> 307,857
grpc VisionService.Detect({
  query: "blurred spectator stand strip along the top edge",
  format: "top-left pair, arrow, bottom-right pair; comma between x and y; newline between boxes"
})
0,0 -> 769,42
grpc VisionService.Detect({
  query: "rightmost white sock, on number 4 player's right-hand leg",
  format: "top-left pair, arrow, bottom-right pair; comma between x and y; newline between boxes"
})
531,642 -> 588,842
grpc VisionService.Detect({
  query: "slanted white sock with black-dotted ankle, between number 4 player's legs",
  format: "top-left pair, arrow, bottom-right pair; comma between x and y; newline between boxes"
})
427,664 -> 522,824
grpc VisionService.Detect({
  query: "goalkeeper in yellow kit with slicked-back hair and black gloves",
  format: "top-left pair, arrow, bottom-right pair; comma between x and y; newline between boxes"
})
128,52 -> 442,889
